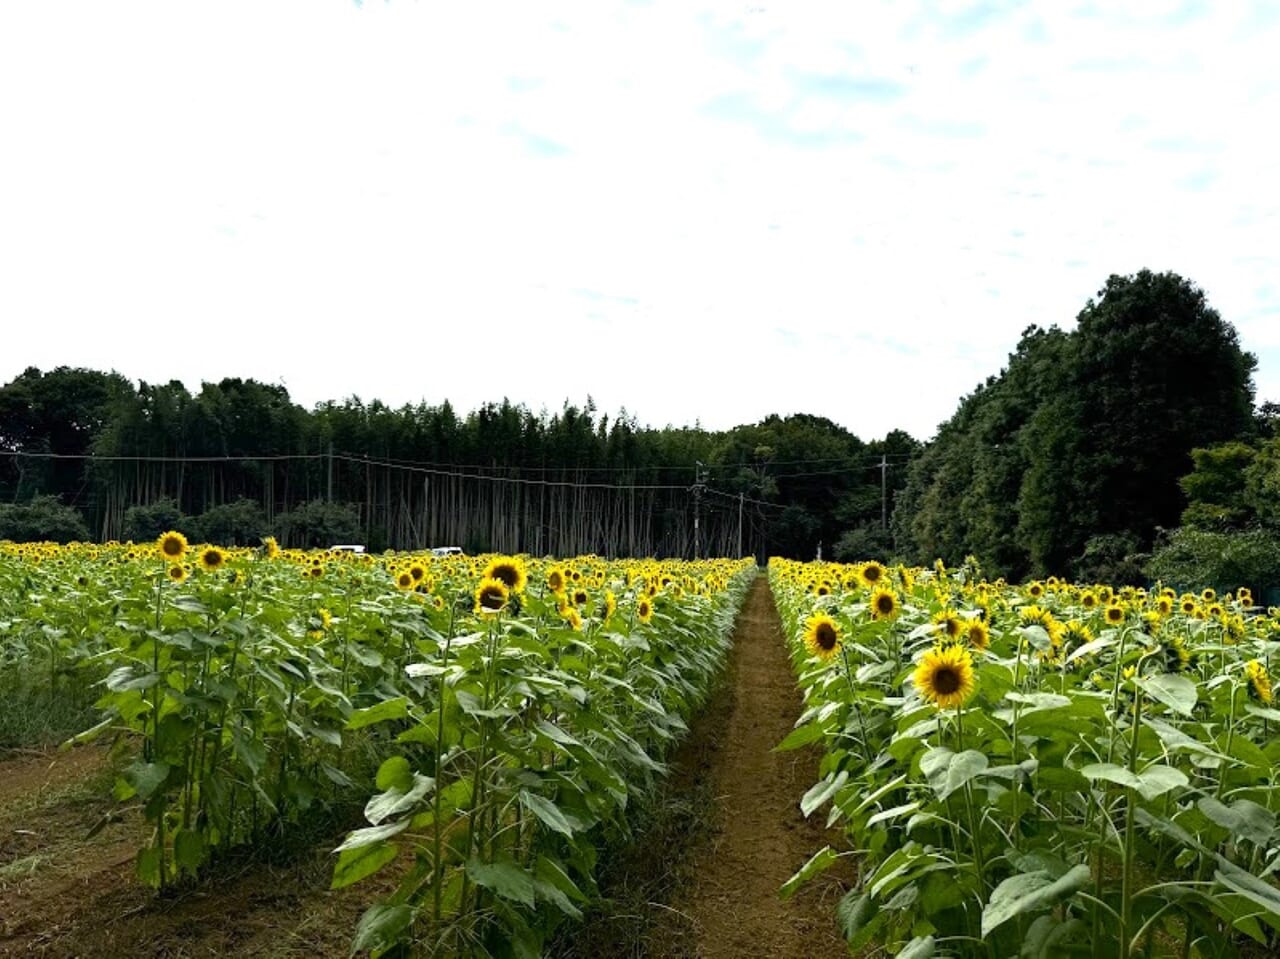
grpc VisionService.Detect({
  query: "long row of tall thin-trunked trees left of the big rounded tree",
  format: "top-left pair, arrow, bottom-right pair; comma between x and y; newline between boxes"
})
0,367 -> 919,560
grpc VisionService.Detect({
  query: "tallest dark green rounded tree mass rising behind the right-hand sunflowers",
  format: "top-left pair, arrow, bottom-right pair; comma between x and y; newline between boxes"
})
895,270 -> 1254,576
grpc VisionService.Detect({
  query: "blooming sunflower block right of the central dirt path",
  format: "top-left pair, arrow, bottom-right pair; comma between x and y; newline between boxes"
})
769,560 -> 1280,959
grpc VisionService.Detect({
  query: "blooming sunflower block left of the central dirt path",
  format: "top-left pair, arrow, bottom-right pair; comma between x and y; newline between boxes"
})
0,531 -> 756,955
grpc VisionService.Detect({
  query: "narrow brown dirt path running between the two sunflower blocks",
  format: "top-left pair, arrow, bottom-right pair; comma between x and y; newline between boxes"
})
673,575 -> 847,959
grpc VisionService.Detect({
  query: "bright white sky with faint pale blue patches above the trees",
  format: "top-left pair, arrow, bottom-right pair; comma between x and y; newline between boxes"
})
0,0 -> 1280,439
